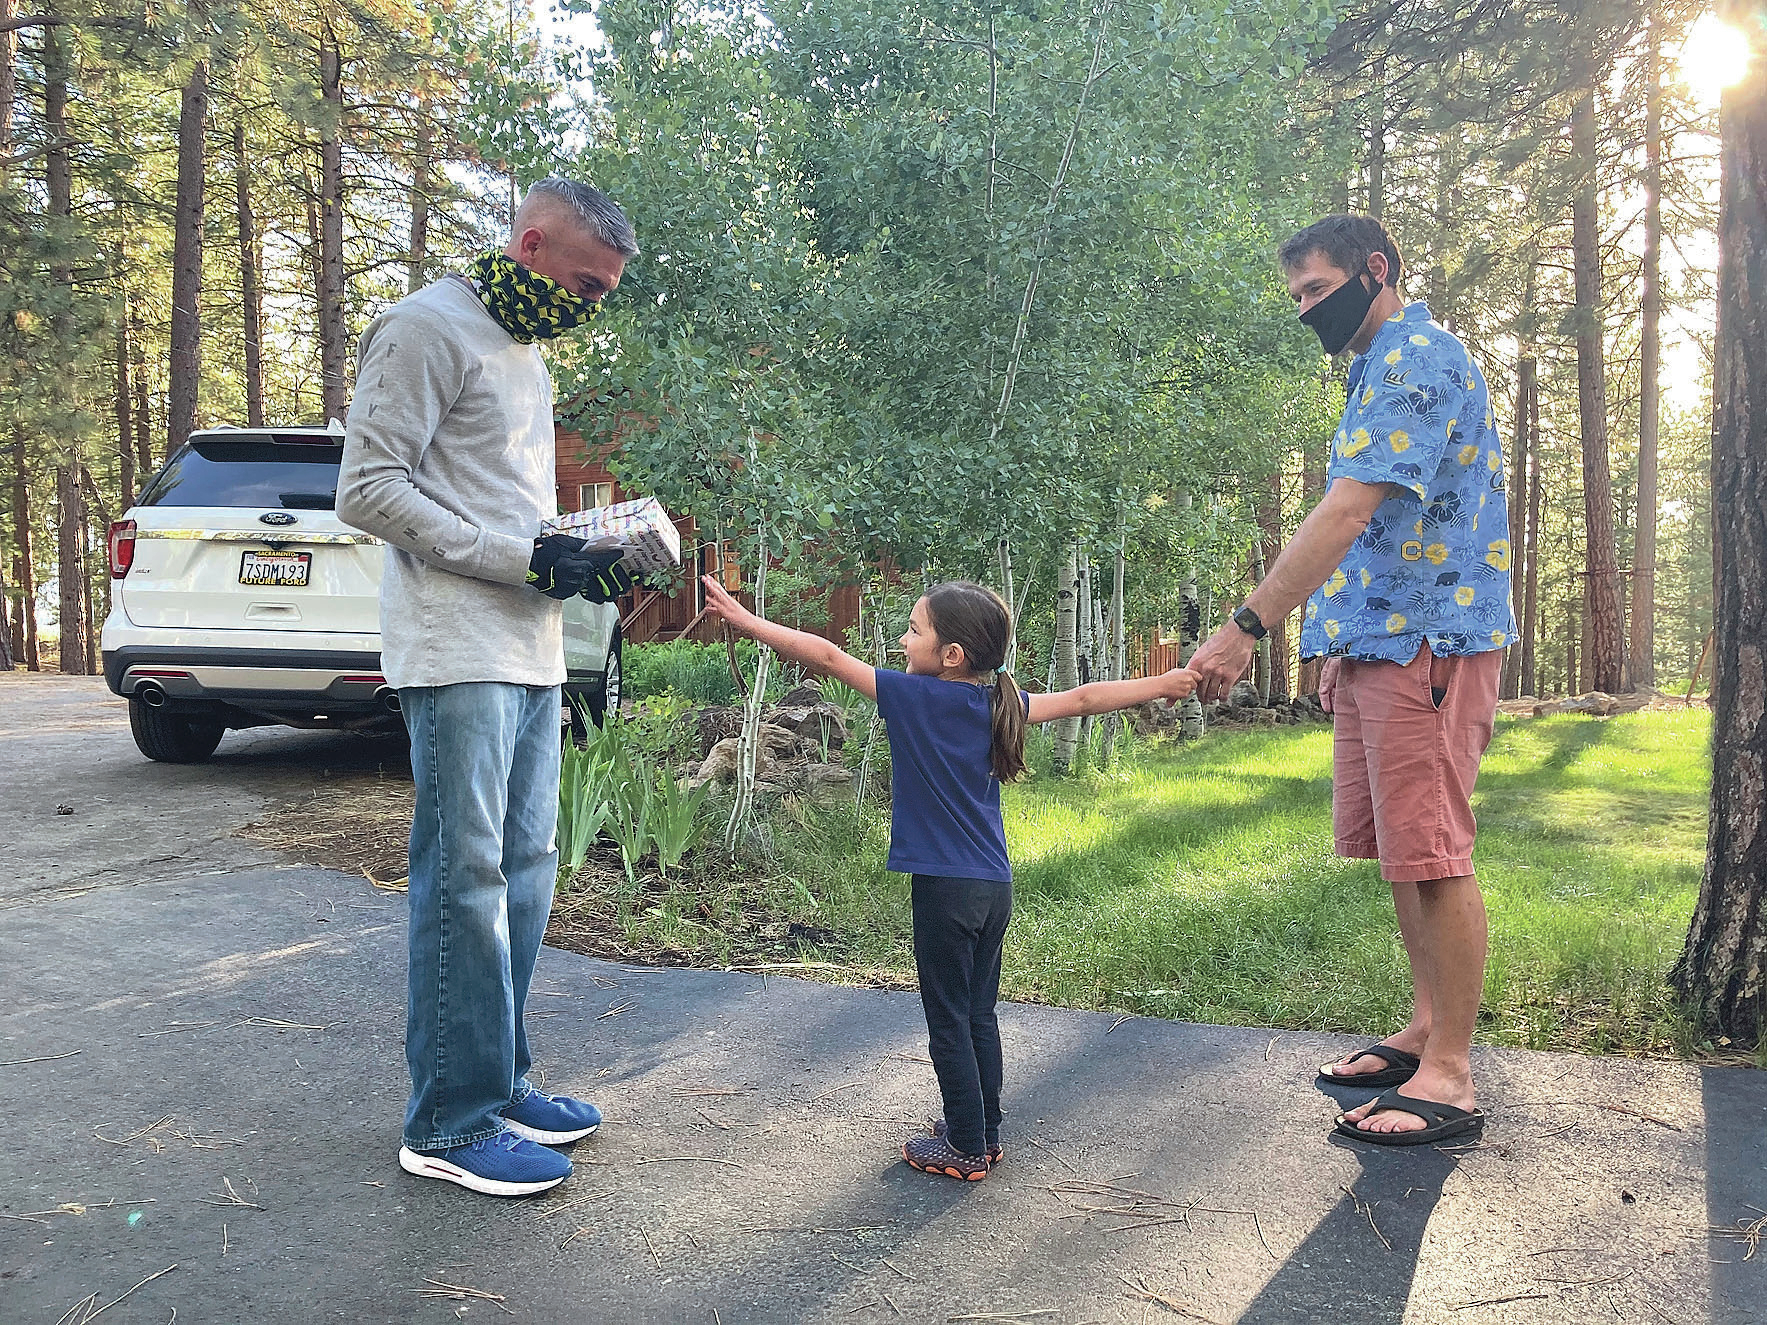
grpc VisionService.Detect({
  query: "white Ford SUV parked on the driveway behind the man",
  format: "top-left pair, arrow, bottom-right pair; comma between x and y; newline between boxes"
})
102,424 -> 620,763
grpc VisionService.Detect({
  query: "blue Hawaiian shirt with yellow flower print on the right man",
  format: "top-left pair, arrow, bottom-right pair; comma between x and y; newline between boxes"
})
1301,302 -> 1518,663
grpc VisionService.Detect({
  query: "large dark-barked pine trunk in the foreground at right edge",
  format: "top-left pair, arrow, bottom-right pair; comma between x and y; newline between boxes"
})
1670,15 -> 1767,1044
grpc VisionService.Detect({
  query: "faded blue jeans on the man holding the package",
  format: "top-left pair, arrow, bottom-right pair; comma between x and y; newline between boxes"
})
399,682 -> 560,1150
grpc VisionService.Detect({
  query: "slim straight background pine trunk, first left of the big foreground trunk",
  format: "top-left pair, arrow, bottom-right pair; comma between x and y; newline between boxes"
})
1626,14 -> 1663,691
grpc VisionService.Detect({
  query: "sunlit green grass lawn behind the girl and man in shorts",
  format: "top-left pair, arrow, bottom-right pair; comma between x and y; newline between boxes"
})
558,712 -> 1709,1053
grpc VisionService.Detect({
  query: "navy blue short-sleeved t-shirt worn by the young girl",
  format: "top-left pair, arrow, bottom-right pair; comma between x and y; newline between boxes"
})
876,668 -> 1012,883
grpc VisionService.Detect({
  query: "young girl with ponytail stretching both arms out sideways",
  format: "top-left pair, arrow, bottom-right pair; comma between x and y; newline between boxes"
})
705,576 -> 1196,1182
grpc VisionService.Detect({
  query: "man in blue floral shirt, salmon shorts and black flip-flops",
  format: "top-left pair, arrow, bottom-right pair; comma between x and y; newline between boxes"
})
1189,216 -> 1516,1145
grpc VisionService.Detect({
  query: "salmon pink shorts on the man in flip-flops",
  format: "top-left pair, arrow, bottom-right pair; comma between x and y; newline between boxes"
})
1331,643 -> 1504,883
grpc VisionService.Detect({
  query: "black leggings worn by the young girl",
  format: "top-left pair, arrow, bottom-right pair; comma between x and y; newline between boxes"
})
912,875 -> 1012,1155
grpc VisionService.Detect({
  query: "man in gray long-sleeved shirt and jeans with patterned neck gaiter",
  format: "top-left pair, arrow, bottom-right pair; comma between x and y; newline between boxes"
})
337,178 -> 638,1196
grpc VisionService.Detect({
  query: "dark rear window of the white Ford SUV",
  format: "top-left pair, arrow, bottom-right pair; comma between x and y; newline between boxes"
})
136,441 -> 343,511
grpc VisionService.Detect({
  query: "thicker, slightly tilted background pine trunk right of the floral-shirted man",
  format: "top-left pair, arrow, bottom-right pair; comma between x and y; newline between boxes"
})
1571,92 -> 1624,694
